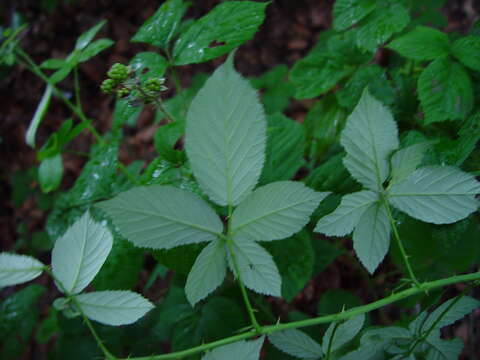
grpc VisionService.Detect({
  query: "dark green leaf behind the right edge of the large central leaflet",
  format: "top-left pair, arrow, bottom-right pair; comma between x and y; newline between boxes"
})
260,113 -> 305,184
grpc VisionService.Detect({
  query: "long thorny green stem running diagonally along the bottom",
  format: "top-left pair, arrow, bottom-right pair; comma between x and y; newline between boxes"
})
119,271 -> 480,360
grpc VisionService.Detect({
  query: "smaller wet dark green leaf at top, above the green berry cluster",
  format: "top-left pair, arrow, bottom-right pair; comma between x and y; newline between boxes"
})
131,0 -> 190,49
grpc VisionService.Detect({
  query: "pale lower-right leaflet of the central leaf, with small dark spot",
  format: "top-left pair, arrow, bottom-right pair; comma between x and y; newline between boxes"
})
228,238 -> 282,297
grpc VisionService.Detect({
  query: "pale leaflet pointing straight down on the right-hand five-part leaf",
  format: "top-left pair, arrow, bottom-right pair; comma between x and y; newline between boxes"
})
353,202 -> 391,274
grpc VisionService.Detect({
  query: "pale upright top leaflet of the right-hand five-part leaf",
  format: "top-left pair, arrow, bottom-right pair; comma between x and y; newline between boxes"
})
341,90 -> 398,191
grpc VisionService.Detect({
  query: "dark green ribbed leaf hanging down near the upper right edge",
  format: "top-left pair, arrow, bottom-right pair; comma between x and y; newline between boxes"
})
418,57 -> 473,124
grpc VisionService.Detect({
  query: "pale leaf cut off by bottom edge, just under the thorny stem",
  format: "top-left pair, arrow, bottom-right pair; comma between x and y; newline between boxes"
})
202,336 -> 265,360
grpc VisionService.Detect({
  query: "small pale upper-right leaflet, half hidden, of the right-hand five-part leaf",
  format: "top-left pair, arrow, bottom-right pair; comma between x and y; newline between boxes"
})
391,142 -> 431,183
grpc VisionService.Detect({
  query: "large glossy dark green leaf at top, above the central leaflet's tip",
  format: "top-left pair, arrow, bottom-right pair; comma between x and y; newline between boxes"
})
173,1 -> 268,65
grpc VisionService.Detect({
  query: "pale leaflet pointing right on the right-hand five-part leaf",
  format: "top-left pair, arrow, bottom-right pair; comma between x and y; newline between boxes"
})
388,166 -> 480,224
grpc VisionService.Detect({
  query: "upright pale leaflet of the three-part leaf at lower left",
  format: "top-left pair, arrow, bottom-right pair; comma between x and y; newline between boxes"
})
52,212 -> 112,294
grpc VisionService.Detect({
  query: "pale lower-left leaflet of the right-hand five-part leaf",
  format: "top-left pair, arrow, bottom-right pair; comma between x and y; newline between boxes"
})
314,190 -> 378,236
